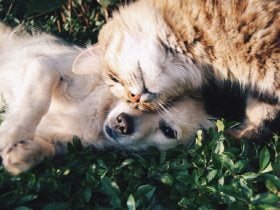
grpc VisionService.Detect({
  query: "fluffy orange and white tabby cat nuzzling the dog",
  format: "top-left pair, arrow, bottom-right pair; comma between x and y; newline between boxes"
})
74,0 -> 280,138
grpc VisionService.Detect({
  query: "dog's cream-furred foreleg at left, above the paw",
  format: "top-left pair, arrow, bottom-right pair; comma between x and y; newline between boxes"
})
0,57 -> 59,151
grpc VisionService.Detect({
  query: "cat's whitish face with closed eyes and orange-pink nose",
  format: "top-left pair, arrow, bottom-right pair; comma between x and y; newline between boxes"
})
100,33 -> 190,111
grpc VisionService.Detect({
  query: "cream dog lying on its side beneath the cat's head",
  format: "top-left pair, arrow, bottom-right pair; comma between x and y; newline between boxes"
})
0,24 -> 212,174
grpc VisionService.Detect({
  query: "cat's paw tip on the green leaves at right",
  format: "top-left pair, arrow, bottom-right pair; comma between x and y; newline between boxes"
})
226,124 -> 258,139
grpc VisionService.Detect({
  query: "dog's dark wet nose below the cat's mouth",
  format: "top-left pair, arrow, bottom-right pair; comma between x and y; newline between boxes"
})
114,113 -> 134,135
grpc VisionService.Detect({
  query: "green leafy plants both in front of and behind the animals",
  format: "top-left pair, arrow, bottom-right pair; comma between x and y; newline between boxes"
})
0,0 -> 280,210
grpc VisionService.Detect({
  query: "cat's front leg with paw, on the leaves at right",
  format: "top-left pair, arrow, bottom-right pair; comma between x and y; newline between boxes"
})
227,97 -> 280,140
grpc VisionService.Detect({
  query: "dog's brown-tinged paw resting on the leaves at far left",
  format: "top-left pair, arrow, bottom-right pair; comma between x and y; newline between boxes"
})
1,140 -> 45,175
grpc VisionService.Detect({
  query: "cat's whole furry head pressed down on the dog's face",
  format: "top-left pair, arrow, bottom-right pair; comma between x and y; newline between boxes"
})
72,1 -> 201,111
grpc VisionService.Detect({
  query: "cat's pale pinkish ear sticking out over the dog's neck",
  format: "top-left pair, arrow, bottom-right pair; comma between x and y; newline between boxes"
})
72,44 -> 102,74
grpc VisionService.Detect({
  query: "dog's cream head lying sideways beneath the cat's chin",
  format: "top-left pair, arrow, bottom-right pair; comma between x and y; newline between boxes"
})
103,98 -> 212,150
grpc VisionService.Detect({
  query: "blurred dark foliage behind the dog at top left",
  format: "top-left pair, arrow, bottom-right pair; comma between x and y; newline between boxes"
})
0,0 -> 129,45
